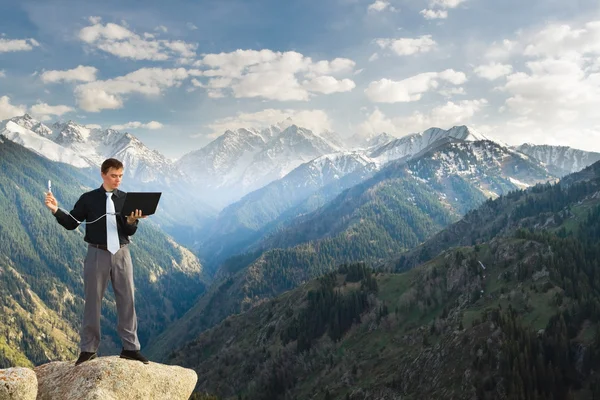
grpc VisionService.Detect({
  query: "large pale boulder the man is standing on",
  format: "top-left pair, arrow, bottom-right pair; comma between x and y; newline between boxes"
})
35,356 -> 198,400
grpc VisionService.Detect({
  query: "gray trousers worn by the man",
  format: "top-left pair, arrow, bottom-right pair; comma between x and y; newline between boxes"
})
80,246 -> 140,353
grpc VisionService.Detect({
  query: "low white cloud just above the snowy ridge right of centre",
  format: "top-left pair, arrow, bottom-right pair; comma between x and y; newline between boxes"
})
358,99 -> 487,137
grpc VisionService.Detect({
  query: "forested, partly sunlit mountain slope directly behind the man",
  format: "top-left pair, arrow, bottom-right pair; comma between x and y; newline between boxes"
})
0,135 -> 206,368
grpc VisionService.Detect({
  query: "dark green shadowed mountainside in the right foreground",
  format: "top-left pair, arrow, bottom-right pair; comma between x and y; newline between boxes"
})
168,163 -> 600,400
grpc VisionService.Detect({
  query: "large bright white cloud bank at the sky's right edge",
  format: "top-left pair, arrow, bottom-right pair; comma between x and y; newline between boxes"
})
488,21 -> 600,149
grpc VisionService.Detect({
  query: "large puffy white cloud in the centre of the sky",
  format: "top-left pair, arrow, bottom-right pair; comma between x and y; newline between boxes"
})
194,49 -> 355,101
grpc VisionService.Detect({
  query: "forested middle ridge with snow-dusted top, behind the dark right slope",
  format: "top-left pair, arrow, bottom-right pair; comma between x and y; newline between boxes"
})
149,139 -> 556,359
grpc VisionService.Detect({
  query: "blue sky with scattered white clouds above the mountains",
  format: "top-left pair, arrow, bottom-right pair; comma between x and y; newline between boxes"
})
0,0 -> 600,159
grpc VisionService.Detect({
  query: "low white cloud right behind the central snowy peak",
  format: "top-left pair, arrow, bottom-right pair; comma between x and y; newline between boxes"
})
204,108 -> 331,137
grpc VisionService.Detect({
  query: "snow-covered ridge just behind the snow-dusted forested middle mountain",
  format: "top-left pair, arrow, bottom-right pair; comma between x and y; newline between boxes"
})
369,125 -> 490,164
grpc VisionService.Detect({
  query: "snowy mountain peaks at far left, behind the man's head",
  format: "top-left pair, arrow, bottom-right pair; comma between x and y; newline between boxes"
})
0,114 -> 182,183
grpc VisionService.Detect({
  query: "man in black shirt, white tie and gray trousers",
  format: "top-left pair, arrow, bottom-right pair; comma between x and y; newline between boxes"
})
45,158 -> 148,365
